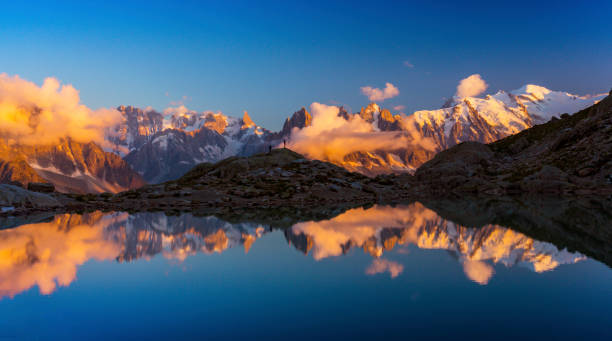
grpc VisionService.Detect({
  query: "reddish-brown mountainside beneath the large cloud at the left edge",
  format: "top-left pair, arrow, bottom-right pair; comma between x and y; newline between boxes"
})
0,138 -> 145,193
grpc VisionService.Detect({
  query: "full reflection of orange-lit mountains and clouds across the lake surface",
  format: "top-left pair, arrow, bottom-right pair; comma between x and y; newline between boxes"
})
0,203 -> 586,297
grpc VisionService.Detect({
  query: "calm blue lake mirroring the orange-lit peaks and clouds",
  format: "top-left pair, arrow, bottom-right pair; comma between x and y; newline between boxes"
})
0,203 -> 612,340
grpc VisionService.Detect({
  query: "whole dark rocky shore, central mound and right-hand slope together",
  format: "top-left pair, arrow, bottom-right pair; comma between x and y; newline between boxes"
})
1,86 -> 612,211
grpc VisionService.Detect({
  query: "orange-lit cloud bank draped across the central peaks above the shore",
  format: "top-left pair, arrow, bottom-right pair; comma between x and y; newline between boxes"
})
289,103 -> 417,163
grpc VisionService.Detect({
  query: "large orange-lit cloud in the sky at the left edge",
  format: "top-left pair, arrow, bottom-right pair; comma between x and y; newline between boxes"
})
0,73 -> 121,145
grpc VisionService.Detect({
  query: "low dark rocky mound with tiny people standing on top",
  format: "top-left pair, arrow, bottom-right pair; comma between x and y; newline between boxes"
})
0,149 -> 410,214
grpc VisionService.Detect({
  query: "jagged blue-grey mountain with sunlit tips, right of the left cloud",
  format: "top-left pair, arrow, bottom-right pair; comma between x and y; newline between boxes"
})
107,106 -> 273,183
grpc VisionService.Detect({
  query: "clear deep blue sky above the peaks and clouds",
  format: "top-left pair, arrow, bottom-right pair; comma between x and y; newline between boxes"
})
0,1 -> 612,129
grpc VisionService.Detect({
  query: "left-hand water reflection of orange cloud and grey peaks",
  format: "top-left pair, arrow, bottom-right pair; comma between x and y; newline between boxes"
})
0,212 -> 265,299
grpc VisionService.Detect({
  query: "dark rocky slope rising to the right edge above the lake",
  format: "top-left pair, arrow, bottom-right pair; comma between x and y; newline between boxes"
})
414,92 -> 612,195
